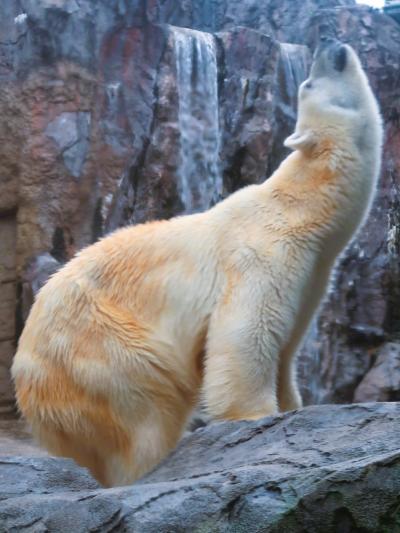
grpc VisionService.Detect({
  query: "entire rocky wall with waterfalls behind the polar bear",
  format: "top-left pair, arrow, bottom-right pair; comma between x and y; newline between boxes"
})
0,0 -> 400,416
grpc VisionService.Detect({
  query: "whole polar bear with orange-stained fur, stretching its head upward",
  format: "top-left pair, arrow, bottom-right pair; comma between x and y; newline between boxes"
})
12,40 -> 382,486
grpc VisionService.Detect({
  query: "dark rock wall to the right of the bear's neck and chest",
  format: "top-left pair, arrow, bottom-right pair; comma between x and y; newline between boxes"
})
294,8 -> 400,403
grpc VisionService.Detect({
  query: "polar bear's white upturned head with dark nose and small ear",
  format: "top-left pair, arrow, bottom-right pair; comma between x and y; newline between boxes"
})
285,38 -> 382,157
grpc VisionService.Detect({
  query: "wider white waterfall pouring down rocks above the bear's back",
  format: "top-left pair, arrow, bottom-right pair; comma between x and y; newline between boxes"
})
173,28 -> 222,213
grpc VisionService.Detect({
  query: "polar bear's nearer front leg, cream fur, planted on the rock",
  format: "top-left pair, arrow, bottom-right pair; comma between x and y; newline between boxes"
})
203,279 -> 279,420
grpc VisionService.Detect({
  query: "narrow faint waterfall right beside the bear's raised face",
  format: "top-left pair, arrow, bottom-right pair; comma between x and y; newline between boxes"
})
280,43 -> 311,118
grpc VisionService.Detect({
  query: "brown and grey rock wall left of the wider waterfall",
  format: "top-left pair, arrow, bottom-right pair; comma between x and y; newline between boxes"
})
0,6 -> 174,410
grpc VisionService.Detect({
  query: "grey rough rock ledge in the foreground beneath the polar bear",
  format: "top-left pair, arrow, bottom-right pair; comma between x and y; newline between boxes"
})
0,403 -> 400,533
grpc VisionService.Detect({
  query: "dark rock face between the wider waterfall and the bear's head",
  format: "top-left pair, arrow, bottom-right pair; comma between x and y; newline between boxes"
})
217,27 -> 311,193
